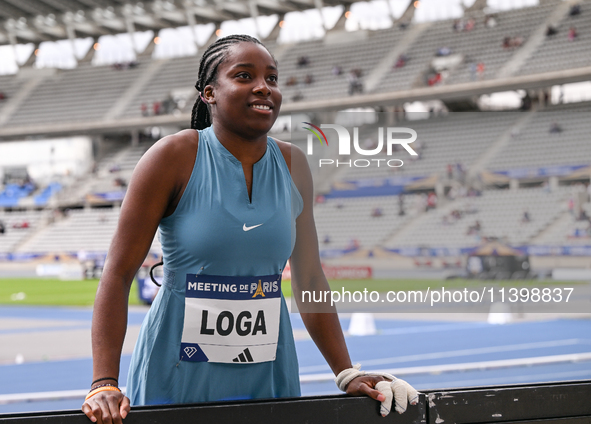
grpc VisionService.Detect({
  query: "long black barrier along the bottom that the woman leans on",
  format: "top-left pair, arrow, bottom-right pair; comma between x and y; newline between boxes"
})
0,380 -> 591,424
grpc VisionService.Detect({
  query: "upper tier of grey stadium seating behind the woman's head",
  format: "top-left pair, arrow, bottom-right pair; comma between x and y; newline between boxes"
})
0,0 -> 591,131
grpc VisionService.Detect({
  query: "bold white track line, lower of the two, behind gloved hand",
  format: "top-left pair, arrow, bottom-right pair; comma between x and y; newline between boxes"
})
300,352 -> 591,383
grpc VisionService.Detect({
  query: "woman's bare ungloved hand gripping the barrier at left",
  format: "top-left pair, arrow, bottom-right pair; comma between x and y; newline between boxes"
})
82,391 -> 130,424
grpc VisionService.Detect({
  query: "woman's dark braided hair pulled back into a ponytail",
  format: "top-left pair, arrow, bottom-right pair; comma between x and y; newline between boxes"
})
191,34 -> 275,130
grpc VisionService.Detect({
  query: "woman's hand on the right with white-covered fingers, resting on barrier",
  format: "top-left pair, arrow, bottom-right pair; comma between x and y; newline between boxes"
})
347,375 -> 419,417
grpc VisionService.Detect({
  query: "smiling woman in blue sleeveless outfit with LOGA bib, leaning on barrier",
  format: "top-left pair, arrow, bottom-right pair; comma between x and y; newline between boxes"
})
82,35 -> 418,424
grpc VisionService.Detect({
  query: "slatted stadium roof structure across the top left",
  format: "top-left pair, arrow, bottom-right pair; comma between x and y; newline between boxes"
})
0,0 -> 354,45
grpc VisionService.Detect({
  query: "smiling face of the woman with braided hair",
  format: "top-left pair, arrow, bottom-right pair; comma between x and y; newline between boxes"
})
204,42 -> 282,138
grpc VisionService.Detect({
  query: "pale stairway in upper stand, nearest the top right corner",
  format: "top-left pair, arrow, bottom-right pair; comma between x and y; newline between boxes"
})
497,0 -> 577,78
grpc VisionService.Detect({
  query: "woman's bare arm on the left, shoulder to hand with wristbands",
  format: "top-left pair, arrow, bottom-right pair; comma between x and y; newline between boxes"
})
82,131 -> 198,423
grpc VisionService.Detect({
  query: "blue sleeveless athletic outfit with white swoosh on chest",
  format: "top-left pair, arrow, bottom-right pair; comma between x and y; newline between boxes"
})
127,127 -> 303,405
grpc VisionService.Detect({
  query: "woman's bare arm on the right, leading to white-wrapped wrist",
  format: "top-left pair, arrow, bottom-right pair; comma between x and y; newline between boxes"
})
291,146 -> 385,402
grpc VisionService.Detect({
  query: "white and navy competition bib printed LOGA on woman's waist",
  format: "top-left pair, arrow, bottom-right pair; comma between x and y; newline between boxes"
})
180,274 -> 281,363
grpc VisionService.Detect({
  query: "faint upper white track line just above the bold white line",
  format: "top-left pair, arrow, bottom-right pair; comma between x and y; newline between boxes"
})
300,339 -> 591,373
